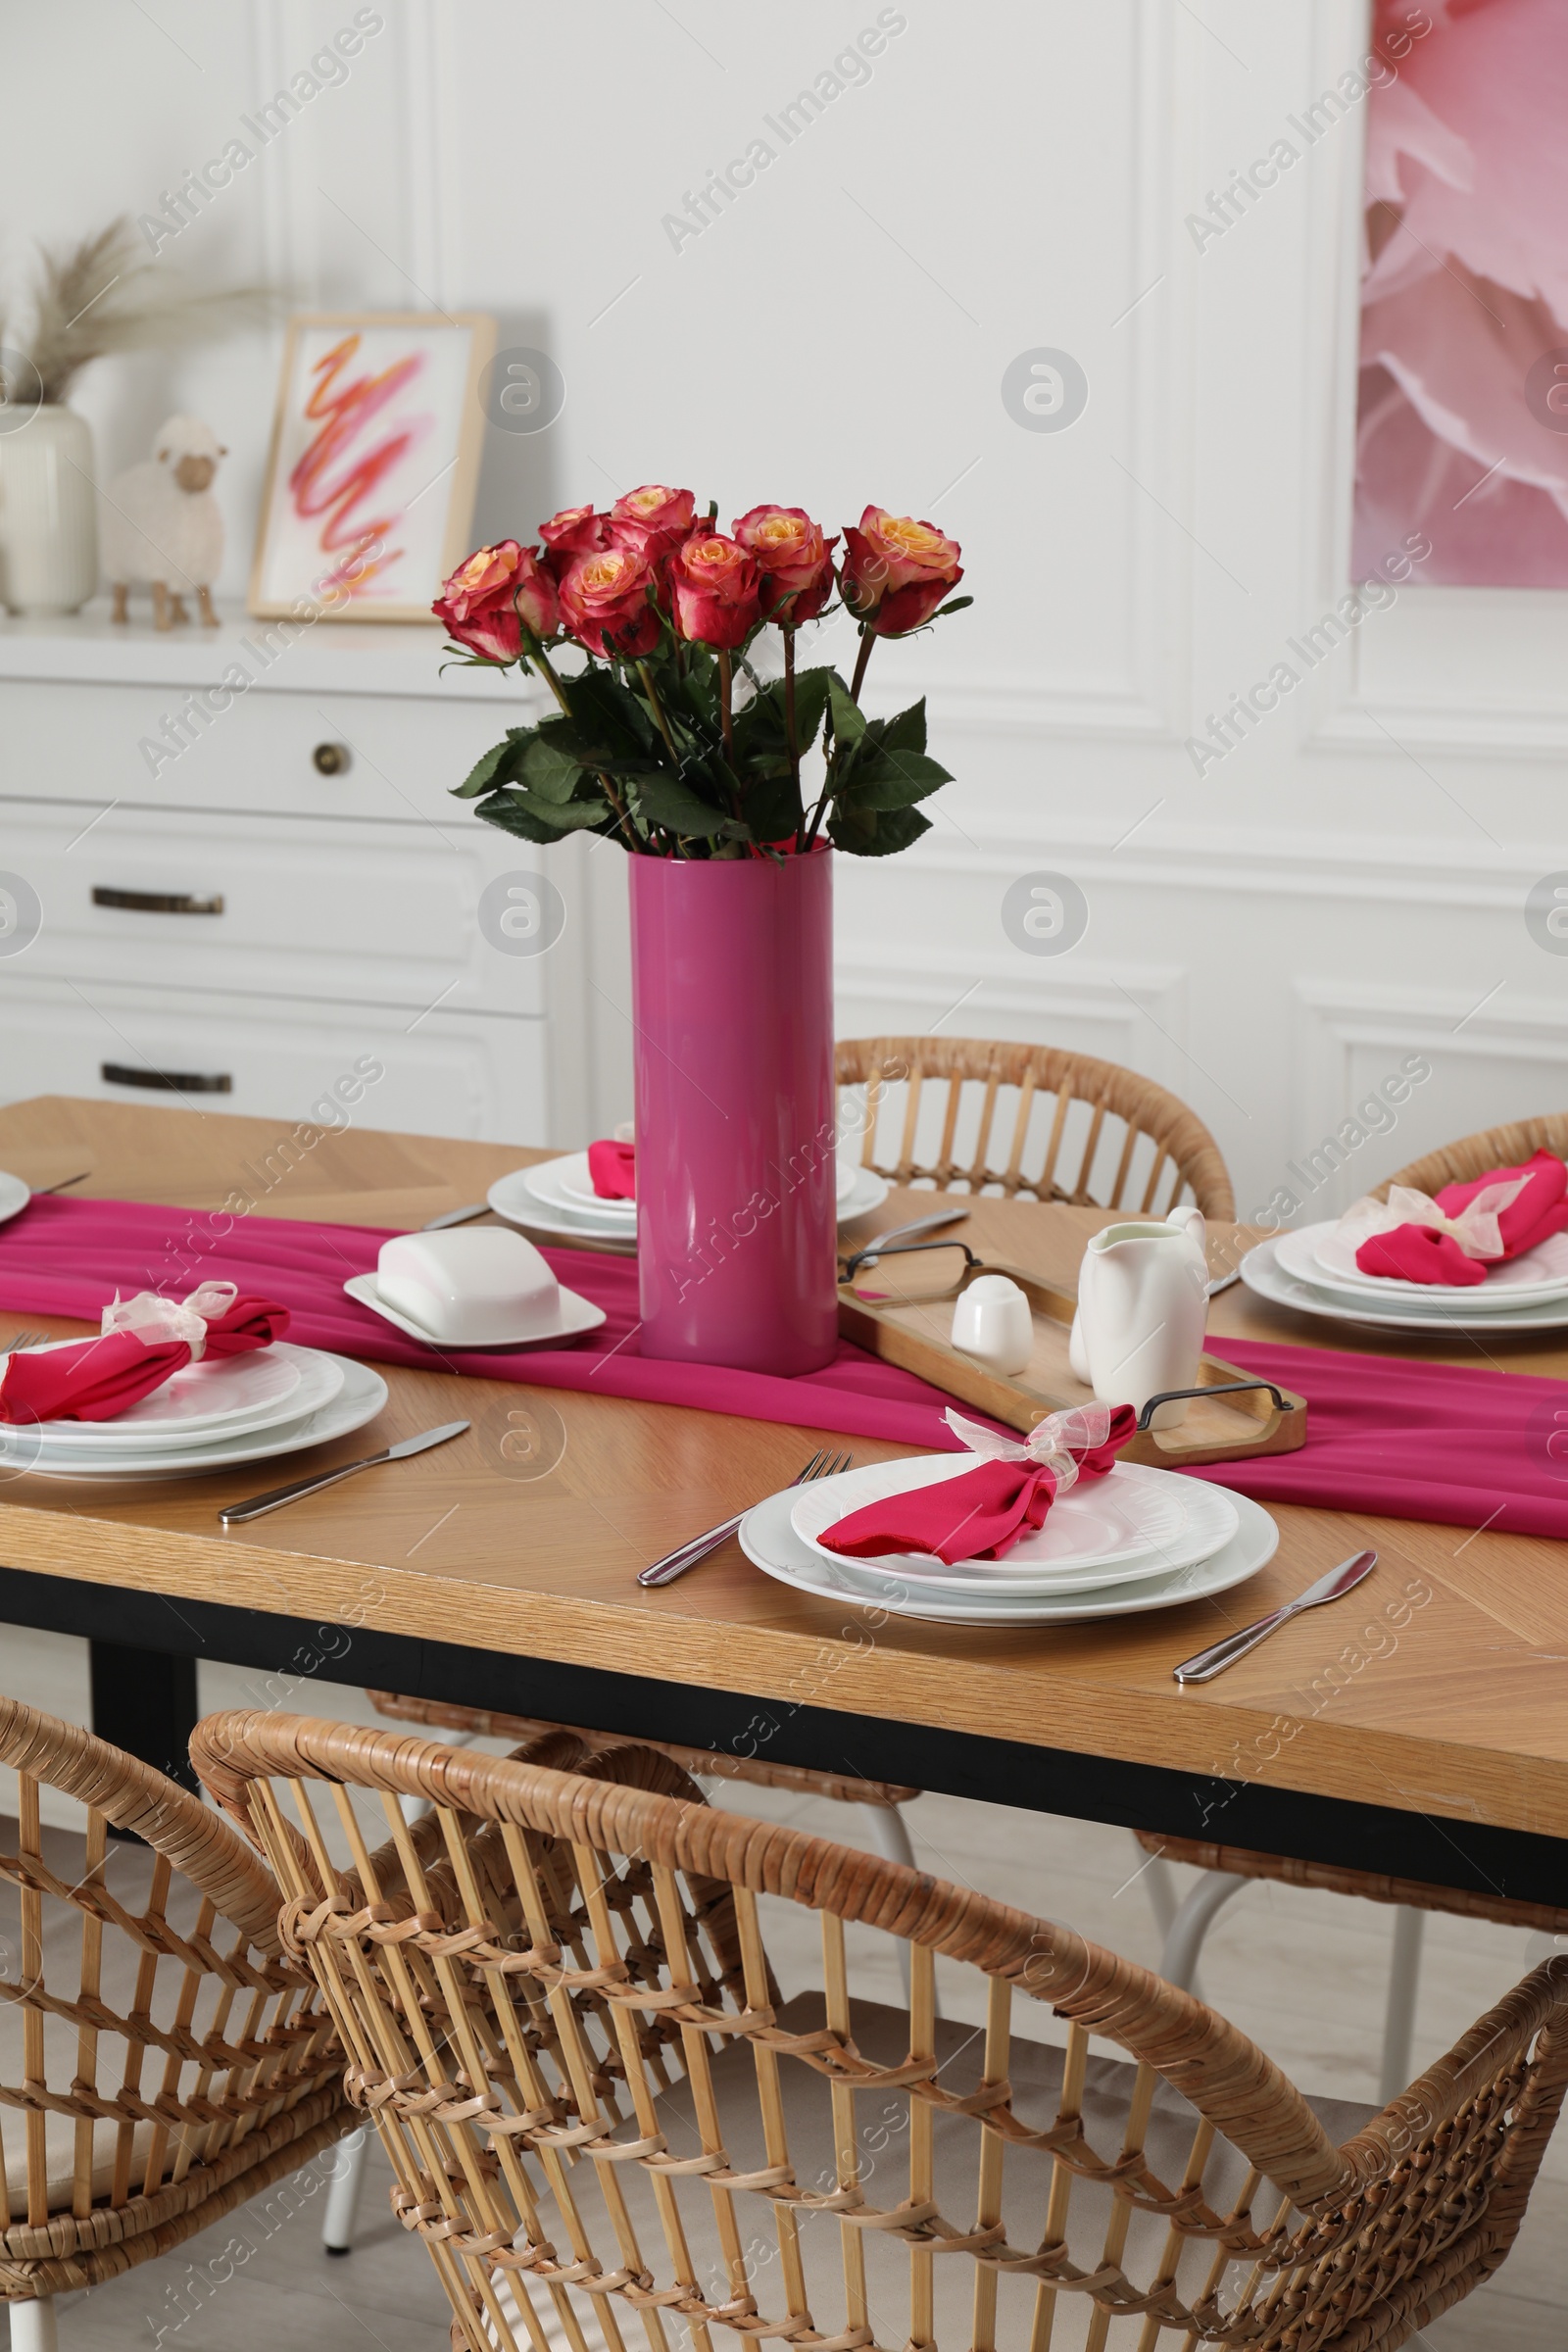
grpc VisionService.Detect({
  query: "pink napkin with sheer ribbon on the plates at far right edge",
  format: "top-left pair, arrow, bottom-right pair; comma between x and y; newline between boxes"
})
1338,1152 -> 1568,1289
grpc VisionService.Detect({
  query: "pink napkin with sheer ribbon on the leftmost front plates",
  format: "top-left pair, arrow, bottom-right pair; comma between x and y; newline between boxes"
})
0,1282 -> 289,1428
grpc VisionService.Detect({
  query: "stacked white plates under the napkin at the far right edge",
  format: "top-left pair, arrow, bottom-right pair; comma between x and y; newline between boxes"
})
1242,1223 -> 1568,1331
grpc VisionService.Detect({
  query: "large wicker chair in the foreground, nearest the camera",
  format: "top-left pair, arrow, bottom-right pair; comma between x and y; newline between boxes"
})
190,1712 -> 1568,2352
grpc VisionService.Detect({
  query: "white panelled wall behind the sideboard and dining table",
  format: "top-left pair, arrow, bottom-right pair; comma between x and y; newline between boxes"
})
0,0 -> 1568,1204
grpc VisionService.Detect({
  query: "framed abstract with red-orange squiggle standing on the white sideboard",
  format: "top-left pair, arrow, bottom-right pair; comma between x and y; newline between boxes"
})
249,311 -> 496,621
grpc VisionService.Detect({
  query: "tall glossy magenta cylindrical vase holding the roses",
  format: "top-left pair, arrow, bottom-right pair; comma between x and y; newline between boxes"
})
630,847 -> 839,1374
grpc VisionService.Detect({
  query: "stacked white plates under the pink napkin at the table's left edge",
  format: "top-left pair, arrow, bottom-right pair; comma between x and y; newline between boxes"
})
0,1341 -> 388,1480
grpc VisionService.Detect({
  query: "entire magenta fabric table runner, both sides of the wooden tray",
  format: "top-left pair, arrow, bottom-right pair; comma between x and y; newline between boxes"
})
0,1198 -> 1568,1539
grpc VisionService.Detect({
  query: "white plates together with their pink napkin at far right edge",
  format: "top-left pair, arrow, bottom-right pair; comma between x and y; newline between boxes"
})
1242,1151 -> 1568,1334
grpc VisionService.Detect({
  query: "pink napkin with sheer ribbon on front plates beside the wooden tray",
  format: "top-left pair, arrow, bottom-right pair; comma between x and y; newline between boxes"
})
818,1404 -> 1138,1566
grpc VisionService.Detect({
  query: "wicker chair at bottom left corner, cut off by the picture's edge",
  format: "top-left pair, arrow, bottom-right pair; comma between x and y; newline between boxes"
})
0,1698 -> 360,2352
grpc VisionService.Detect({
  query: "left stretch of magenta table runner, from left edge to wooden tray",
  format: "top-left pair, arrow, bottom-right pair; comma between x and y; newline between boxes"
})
0,1195 -> 982,1453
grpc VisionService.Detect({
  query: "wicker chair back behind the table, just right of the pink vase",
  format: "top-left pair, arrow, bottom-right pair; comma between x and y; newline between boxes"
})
837,1037 -> 1237,1218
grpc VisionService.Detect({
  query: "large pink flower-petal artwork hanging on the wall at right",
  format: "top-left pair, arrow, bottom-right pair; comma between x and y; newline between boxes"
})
1351,0 -> 1568,588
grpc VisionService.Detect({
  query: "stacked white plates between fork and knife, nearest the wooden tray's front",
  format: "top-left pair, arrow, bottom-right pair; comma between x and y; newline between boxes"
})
741,1453 -> 1279,1625
